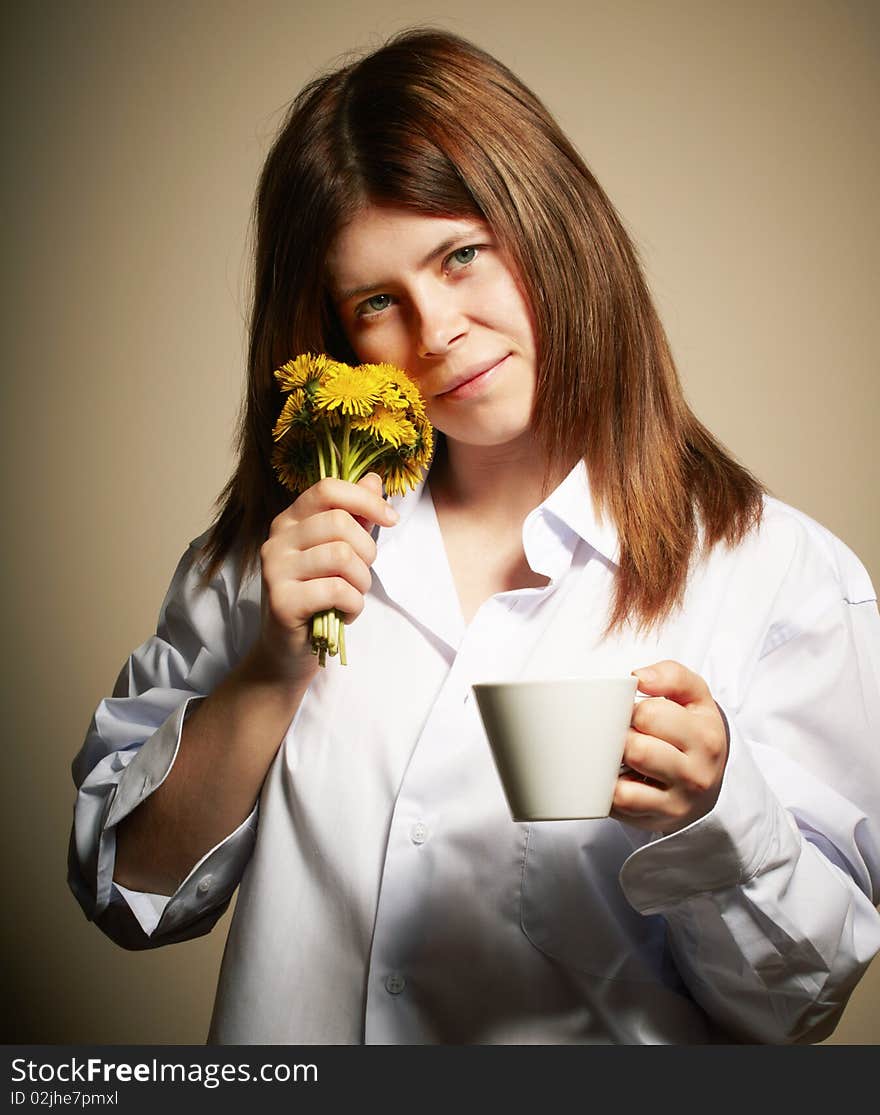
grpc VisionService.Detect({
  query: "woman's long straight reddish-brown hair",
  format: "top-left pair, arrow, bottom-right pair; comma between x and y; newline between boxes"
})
199,29 -> 763,629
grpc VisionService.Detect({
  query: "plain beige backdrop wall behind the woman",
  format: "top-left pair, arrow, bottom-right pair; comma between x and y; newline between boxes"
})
2,0 -> 880,1044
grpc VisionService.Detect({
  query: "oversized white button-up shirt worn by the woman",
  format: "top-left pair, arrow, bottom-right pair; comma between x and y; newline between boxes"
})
70,465 -> 880,1045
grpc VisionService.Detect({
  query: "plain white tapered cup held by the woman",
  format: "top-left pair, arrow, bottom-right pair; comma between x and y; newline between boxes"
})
472,676 -> 638,821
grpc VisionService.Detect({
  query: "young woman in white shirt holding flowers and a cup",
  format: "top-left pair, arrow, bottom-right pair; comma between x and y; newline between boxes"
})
70,30 -> 880,1044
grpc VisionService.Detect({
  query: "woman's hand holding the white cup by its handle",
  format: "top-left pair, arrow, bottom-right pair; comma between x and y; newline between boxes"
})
611,661 -> 728,834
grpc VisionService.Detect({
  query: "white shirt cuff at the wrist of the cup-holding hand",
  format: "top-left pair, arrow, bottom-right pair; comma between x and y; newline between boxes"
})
619,717 -> 801,914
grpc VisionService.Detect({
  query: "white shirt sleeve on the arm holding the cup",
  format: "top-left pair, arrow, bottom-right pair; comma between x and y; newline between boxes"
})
620,517 -> 880,1043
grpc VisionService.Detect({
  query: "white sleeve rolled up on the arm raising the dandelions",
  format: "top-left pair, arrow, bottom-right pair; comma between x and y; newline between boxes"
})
68,539 -> 259,949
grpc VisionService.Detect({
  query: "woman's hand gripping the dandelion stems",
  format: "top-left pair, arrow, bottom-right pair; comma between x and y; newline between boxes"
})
250,473 -> 398,682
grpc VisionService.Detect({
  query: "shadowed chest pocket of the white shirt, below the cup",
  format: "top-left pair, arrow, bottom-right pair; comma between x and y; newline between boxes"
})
520,820 -> 679,986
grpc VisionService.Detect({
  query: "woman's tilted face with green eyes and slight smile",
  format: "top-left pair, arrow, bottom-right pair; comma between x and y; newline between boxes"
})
328,206 -> 536,446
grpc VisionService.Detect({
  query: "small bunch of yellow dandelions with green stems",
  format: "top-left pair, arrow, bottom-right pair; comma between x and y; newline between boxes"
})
272,352 -> 434,666
